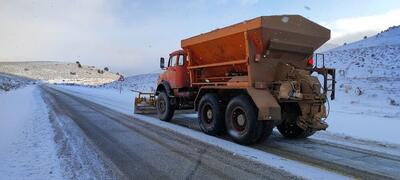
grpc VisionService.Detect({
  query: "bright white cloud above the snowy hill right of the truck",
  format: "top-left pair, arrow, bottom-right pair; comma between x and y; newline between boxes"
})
321,9 -> 400,43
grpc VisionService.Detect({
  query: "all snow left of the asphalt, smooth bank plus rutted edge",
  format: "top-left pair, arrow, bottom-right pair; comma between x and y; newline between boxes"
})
0,85 -> 122,180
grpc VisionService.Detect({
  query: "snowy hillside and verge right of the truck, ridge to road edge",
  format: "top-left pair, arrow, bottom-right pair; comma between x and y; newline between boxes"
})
324,27 -> 400,144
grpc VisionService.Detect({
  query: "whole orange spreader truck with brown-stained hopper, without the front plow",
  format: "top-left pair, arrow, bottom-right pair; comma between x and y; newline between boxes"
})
143,15 -> 335,144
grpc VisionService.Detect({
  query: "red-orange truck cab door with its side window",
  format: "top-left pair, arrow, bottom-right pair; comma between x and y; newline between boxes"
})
167,54 -> 189,89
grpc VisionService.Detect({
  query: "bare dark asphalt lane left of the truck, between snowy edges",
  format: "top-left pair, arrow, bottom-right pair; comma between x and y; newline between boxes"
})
42,86 -> 298,179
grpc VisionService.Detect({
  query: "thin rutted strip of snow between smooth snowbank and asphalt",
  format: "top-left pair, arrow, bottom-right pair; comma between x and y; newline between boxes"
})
42,89 -> 125,180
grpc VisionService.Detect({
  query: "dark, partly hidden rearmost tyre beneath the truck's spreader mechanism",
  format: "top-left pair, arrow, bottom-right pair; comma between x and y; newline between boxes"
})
277,105 -> 315,139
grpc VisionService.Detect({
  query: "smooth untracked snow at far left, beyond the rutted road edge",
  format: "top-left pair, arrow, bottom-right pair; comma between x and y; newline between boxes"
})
0,86 -> 63,179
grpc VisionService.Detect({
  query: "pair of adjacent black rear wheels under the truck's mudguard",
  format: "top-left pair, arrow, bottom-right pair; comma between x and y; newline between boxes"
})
198,94 -> 274,145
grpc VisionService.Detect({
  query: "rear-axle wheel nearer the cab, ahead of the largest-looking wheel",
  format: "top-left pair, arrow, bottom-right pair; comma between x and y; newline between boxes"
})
198,94 -> 224,135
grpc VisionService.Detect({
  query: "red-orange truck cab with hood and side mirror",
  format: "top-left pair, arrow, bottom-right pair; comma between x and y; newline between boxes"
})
158,50 -> 190,89
